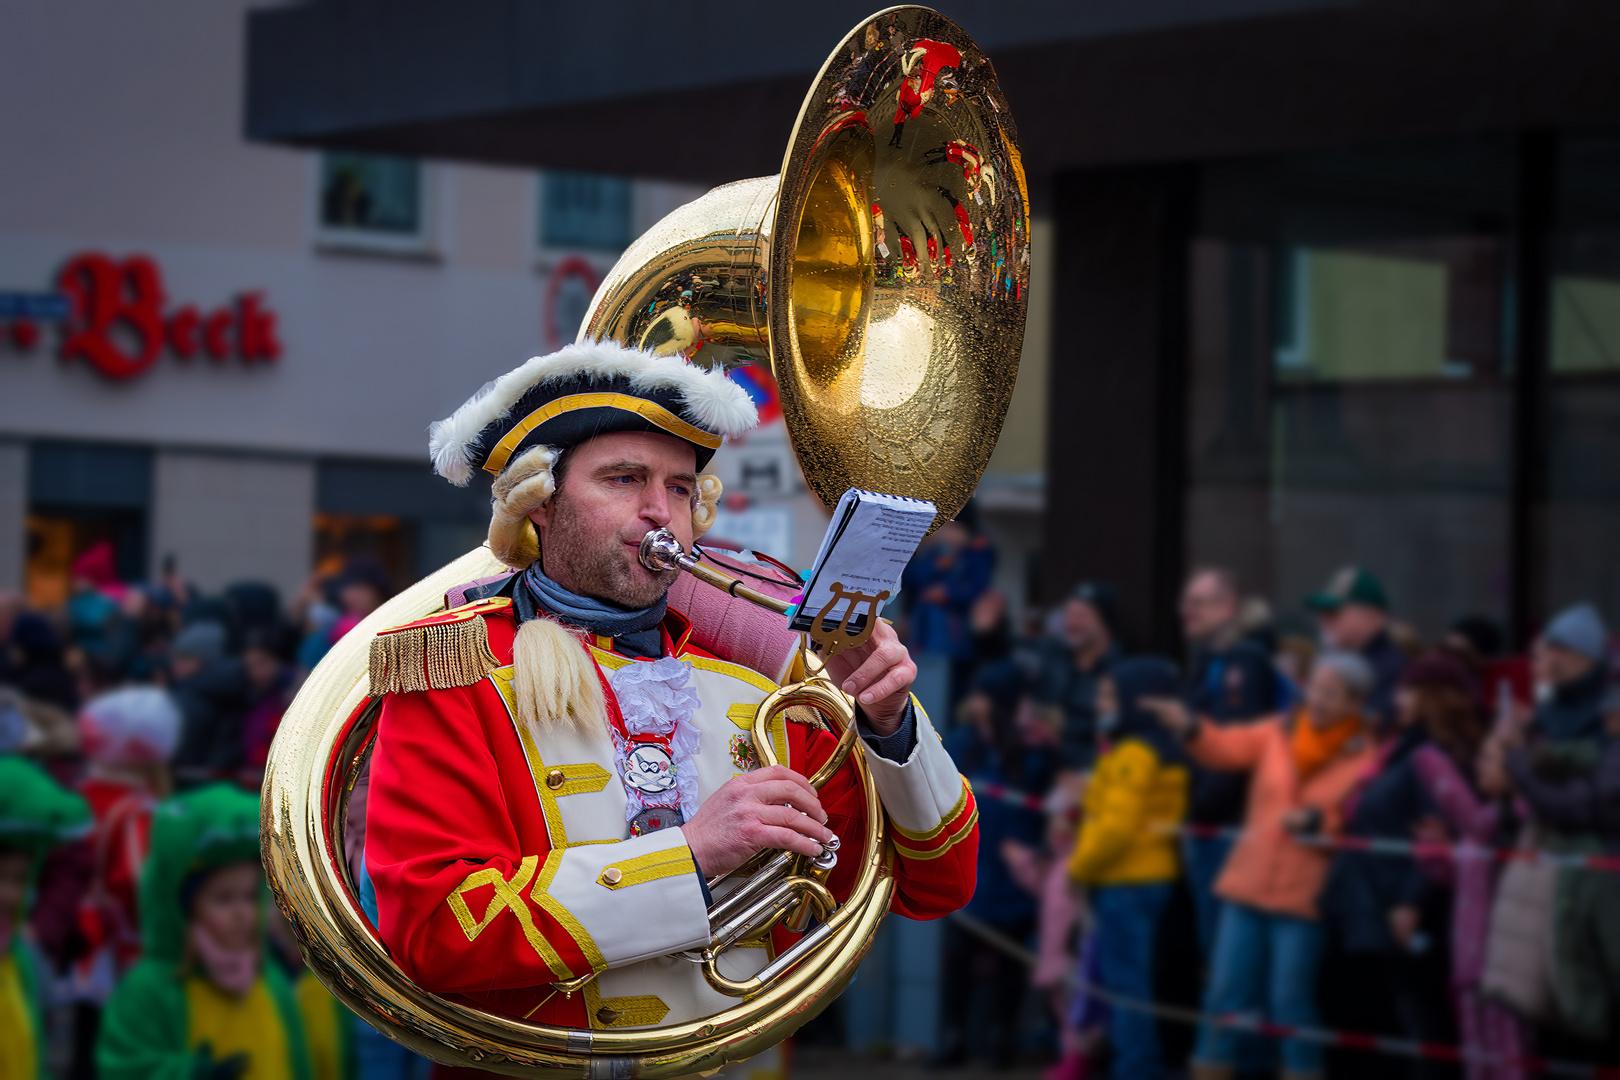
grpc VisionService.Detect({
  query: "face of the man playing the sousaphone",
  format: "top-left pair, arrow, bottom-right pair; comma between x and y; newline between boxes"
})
530,431 -> 698,609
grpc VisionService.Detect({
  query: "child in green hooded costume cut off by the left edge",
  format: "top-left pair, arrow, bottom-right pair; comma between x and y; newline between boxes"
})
0,756 -> 91,1077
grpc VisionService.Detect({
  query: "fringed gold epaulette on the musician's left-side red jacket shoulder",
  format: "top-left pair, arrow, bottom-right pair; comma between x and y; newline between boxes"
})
369,596 -> 512,698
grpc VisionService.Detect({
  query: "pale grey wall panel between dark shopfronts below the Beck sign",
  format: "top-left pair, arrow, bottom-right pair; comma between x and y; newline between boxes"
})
151,452 -> 316,602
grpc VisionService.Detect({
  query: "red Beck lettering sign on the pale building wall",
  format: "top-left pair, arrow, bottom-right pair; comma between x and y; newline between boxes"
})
57,253 -> 282,379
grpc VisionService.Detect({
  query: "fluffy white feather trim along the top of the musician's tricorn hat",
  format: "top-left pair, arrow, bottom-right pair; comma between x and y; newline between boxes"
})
428,342 -> 760,487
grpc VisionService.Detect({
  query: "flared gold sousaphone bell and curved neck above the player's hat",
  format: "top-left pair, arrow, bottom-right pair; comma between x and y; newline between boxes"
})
578,6 -> 1029,526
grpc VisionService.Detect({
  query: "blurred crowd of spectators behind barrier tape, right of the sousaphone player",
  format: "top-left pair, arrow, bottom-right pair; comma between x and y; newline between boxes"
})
910,524 -> 1620,1080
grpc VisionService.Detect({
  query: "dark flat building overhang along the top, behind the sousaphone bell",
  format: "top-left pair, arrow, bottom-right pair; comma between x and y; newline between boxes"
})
246,0 -> 1620,181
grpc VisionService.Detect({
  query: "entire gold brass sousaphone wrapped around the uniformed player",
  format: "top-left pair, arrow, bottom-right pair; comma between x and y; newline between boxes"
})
262,6 -> 1029,1078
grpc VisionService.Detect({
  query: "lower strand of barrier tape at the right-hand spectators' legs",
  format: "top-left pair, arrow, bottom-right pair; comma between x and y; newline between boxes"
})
951,912 -> 1620,1080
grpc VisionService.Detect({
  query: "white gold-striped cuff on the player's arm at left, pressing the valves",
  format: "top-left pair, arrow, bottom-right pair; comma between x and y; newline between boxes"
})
535,829 -> 710,967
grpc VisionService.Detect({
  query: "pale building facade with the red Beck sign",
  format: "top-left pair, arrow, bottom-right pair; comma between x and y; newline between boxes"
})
0,2 -> 729,606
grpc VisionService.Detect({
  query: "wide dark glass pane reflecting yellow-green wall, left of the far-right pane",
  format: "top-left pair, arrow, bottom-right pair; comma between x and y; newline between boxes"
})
1186,139 -> 1515,640
